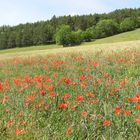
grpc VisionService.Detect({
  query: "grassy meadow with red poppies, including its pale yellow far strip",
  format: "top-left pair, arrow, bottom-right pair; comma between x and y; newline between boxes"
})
0,29 -> 140,140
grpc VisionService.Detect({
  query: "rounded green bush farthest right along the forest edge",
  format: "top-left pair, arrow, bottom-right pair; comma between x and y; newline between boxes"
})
120,18 -> 136,32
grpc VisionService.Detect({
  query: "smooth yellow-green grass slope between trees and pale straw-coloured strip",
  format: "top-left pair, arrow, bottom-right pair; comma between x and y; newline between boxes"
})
0,29 -> 140,54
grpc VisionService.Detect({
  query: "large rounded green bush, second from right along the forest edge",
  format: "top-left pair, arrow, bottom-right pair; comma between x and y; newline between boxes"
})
95,19 -> 119,38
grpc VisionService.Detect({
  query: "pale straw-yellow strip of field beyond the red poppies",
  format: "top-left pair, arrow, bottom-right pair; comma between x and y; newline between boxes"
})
0,41 -> 140,60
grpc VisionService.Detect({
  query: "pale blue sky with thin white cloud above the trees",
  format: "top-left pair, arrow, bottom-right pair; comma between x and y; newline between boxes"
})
0,0 -> 140,26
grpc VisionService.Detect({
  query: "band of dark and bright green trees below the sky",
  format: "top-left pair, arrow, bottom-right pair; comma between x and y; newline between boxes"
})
0,8 -> 140,49
